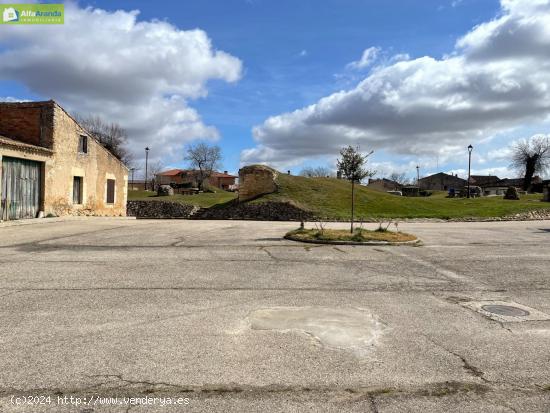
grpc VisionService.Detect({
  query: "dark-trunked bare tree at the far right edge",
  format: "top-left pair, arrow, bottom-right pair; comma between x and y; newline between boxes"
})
510,135 -> 550,191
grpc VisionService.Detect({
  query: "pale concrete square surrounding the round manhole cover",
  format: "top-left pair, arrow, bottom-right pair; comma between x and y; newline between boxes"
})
461,301 -> 550,323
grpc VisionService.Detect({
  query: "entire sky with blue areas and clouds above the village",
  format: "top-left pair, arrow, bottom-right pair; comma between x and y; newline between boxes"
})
0,0 -> 550,177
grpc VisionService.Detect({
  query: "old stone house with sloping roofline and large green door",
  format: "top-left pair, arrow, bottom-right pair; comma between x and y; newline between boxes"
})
0,100 -> 128,220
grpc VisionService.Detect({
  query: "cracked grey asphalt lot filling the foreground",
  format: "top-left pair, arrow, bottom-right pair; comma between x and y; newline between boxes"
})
0,218 -> 550,413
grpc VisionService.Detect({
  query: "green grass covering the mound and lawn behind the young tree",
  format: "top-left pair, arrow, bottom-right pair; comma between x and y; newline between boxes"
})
252,174 -> 550,220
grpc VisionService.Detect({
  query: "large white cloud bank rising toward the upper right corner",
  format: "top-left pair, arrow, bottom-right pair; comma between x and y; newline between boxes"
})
245,0 -> 550,165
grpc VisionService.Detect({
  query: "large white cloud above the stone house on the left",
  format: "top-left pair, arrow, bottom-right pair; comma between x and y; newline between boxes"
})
0,3 -> 242,164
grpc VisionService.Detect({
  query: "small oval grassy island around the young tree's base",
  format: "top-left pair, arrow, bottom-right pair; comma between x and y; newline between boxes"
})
285,228 -> 417,243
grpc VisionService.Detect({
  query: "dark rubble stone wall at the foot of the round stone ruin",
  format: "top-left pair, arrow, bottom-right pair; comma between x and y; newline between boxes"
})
193,202 -> 313,221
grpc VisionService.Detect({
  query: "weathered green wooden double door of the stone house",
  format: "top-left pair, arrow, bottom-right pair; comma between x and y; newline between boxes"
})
0,157 -> 41,221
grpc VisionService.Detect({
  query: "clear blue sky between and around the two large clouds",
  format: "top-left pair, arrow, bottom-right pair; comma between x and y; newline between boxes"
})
0,0 -> 548,176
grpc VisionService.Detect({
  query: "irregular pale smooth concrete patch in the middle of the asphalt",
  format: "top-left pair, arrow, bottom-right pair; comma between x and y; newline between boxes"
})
248,307 -> 385,356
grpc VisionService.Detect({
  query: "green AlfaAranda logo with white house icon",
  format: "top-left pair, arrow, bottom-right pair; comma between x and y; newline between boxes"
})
0,4 -> 65,24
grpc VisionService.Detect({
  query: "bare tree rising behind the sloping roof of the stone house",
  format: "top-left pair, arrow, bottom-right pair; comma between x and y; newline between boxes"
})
76,115 -> 134,166
